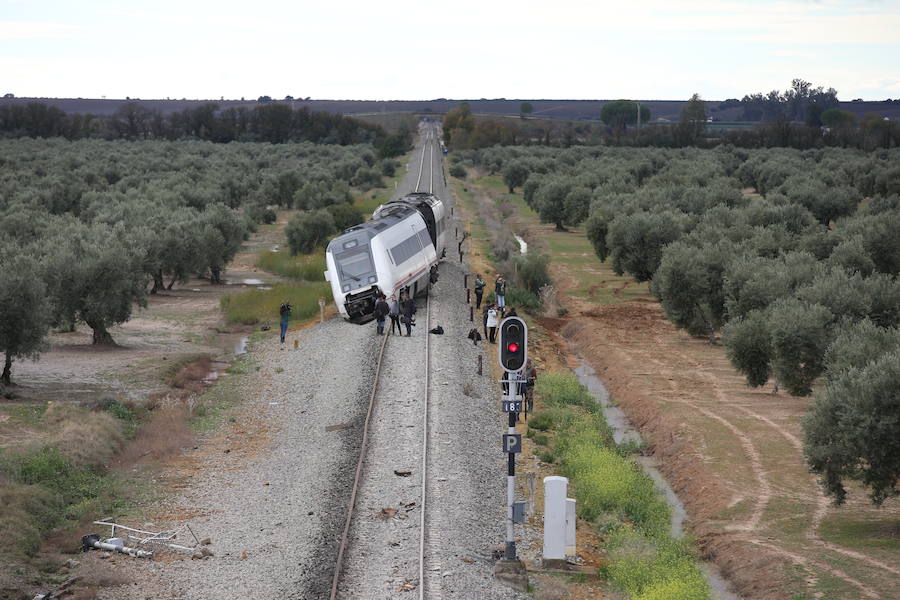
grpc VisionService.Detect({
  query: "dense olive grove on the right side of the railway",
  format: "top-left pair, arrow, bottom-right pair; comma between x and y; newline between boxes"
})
457,146 -> 900,504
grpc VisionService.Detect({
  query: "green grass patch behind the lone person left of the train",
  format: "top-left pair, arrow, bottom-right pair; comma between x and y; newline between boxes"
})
221,281 -> 331,325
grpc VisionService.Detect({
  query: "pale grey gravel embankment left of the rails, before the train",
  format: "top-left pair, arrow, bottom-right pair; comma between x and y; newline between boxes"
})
100,319 -> 376,600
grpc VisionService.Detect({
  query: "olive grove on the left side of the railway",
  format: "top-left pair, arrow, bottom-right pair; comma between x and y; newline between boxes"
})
0,139 -> 397,385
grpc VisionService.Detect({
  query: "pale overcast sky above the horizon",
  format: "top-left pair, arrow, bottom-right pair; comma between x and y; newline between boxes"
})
0,0 -> 900,100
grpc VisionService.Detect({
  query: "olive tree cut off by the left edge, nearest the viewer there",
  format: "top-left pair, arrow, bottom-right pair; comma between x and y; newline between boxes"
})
0,246 -> 52,385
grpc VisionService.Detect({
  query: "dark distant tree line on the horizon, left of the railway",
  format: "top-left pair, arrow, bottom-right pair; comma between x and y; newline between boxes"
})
0,102 -> 412,156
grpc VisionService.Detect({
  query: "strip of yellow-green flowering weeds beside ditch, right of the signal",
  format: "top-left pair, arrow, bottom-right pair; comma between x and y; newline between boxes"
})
528,371 -> 710,600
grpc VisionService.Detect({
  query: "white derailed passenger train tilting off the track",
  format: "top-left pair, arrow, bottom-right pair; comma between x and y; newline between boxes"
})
325,192 -> 447,321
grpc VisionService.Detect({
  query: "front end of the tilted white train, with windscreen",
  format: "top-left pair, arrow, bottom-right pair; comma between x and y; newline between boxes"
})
325,227 -> 384,323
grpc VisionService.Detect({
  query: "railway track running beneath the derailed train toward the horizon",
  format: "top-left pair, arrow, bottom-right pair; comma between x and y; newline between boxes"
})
329,128 -> 437,600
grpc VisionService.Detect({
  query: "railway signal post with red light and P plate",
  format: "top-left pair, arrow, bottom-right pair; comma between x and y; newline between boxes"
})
494,317 -> 528,591
